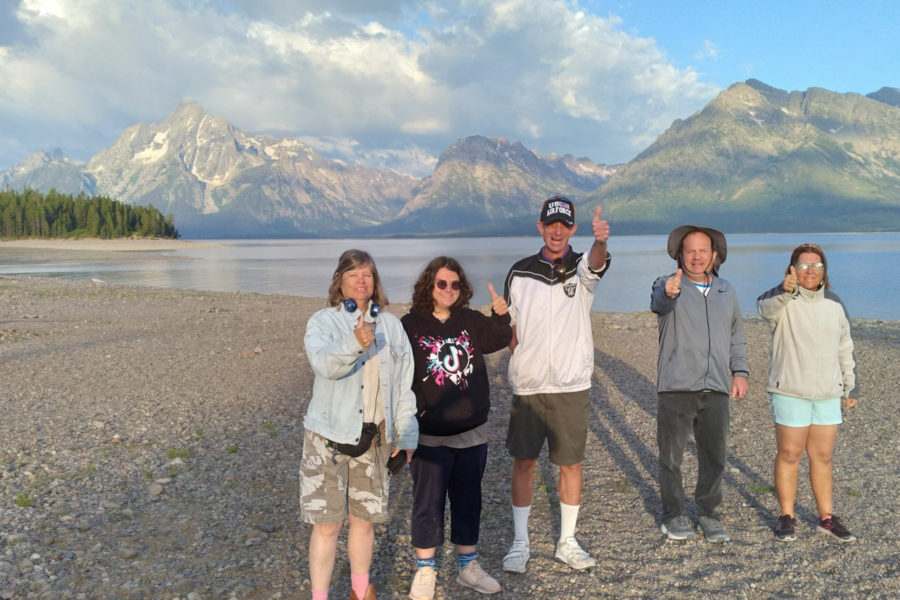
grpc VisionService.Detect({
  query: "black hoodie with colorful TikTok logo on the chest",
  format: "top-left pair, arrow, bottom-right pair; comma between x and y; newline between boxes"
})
401,308 -> 512,436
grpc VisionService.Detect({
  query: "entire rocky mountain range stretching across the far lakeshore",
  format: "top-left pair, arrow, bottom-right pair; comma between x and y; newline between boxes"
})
0,80 -> 900,238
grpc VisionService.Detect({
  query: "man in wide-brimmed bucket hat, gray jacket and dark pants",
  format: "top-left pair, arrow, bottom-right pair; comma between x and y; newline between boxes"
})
650,225 -> 749,542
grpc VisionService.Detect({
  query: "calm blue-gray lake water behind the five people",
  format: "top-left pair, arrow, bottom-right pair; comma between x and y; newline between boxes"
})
0,233 -> 900,320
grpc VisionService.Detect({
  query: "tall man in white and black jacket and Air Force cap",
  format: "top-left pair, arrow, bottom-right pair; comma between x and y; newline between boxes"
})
503,196 -> 610,573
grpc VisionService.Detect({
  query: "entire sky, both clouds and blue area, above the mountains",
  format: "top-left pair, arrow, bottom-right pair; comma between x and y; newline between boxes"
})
0,0 -> 900,176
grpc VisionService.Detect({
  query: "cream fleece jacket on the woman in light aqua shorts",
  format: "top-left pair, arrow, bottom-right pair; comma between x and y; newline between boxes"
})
756,284 -> 859,400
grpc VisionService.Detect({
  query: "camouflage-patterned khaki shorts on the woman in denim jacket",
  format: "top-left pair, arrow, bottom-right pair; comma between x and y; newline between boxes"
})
300,429 -> 390,525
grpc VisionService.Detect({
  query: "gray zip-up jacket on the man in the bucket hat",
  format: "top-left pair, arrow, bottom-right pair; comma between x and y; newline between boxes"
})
650,275 -> 750,395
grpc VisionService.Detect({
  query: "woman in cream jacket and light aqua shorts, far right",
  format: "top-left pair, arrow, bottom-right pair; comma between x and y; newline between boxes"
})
757,244 -> 858,542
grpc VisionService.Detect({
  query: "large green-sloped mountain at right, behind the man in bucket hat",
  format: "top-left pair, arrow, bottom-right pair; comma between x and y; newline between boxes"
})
585,79 -> 900,232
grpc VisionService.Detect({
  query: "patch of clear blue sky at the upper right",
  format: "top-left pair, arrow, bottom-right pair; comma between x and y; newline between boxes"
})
604,0 -> 900,94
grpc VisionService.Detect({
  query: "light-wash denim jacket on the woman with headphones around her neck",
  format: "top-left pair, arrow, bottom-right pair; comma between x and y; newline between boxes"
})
303,306 -> 419,449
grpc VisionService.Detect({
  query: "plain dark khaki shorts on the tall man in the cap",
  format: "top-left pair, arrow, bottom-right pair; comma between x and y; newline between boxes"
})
506,390 -> 590,466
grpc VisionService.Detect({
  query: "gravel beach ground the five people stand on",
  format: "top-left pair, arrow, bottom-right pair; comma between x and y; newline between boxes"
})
0,277 -> 900,600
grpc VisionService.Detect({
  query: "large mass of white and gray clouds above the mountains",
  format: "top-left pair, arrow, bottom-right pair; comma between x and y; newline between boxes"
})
0,0 -> 717,174
